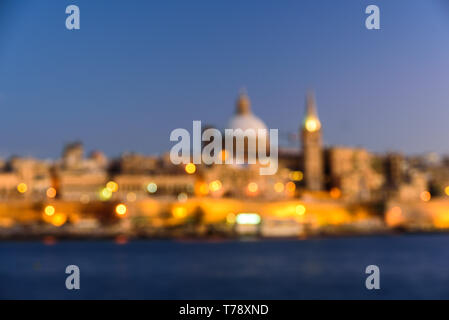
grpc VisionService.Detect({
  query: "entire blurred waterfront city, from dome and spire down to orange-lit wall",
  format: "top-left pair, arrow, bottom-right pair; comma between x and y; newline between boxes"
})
0,92 -> 449,238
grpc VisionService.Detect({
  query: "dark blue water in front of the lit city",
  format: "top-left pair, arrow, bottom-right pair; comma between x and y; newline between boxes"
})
0,235 -> 449,299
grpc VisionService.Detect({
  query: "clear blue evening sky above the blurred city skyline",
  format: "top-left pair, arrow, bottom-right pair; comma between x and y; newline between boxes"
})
0,0 -> 449,157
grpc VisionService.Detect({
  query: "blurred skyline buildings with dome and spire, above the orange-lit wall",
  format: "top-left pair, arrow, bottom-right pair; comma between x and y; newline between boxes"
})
0,90 -> 449,206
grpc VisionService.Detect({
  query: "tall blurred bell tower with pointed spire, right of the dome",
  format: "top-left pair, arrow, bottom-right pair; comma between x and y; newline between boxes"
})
300,93 -> 324,191
